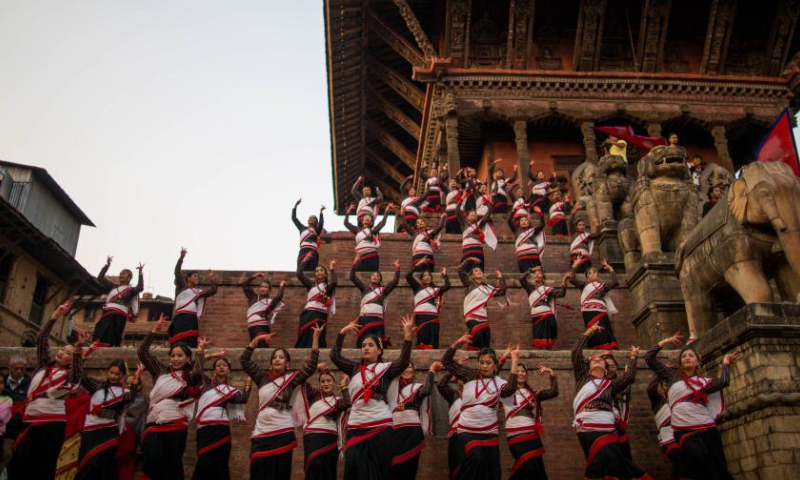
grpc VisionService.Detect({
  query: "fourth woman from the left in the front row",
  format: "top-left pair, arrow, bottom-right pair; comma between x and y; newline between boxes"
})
192,348 -> 251,480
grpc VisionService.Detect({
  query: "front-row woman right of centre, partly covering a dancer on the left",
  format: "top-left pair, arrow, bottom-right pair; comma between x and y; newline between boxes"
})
442,334 -> 519,480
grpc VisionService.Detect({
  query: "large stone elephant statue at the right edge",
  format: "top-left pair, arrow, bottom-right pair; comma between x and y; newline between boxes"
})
676,162 -> 800,335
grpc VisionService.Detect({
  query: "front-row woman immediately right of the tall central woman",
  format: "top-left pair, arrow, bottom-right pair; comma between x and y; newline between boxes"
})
389,362 -> 442,480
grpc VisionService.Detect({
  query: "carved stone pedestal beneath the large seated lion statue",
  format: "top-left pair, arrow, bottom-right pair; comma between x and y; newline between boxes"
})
627,253 -> 687,345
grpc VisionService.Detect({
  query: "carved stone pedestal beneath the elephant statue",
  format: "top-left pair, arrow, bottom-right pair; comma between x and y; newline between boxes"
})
697,303 -> 800,480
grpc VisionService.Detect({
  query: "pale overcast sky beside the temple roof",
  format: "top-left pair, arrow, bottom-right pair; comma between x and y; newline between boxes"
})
0,0 -> 800,296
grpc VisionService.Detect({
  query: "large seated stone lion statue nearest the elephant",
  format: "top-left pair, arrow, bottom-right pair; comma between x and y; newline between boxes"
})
619,145 -> 700,270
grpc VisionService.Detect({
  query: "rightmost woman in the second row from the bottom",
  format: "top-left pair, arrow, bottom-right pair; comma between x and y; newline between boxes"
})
570,260 -> 619,350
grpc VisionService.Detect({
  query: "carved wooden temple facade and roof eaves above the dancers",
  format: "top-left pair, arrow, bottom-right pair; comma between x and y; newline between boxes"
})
325,0 -> 800,213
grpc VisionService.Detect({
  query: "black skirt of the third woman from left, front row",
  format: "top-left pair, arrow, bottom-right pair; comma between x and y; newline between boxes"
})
142,423 -> 188,480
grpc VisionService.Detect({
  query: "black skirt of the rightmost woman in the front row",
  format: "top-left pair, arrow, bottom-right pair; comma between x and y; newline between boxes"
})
675,427 -> 733,480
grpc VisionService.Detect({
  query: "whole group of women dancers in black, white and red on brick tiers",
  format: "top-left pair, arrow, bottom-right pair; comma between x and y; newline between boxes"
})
9,166 -> 738,480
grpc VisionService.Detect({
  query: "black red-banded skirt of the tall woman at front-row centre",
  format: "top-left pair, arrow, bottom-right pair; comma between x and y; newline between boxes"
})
344,427 -> 392,480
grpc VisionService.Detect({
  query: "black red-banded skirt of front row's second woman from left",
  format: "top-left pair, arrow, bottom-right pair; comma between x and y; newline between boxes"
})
75,425 -> 119,480
